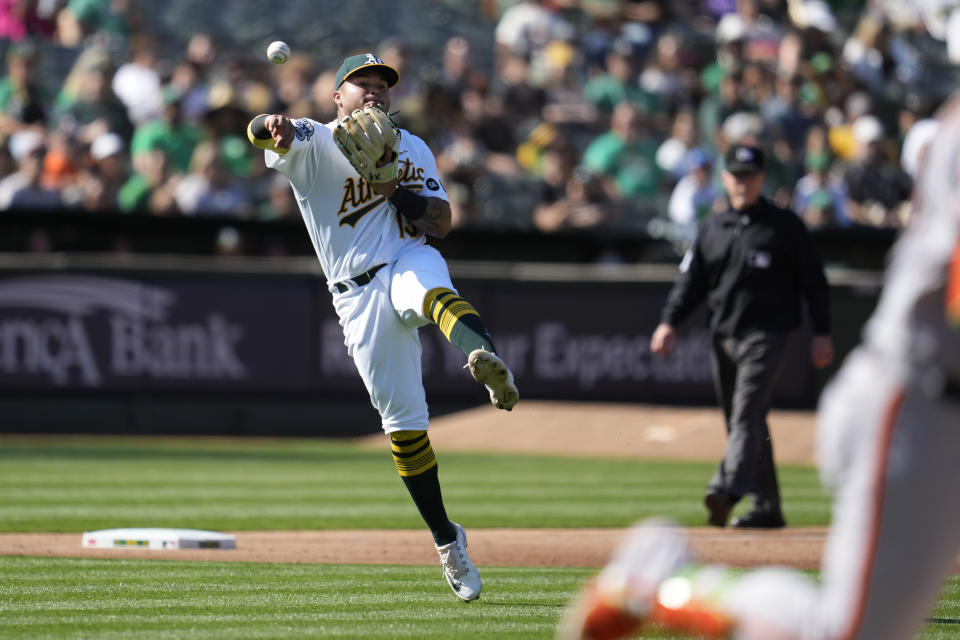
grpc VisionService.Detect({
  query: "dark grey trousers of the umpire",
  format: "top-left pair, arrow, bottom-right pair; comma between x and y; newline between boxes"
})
708,331 -> 788,513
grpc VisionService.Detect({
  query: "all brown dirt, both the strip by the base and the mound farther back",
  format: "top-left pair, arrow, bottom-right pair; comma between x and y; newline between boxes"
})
0,401 -> 840,569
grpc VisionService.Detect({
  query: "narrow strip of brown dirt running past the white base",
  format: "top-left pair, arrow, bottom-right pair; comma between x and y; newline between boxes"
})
0,527 -> 825,569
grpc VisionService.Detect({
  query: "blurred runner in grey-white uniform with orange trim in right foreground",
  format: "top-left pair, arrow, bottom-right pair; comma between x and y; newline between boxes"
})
559,89 -> 960,640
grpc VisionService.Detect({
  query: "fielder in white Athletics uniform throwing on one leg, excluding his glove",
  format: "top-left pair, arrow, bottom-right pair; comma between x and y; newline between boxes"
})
247,53 -> 519,601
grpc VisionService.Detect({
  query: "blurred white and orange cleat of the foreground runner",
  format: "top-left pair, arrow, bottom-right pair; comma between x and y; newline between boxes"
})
556,520 -> 729,640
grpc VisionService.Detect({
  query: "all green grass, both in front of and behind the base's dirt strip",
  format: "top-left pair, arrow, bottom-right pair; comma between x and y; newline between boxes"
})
0,437 -> 960,640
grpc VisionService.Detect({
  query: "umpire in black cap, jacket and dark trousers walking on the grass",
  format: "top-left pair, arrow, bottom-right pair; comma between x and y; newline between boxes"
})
650,145 -> 833,528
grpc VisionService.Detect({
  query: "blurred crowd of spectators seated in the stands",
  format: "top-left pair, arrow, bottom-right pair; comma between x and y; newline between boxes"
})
0,0 -> 960,252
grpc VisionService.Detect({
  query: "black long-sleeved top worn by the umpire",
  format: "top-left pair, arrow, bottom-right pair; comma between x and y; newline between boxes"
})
661,196 -> 830,337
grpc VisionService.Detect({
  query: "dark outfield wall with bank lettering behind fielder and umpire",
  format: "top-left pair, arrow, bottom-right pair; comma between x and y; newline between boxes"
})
0,254 -> 879,435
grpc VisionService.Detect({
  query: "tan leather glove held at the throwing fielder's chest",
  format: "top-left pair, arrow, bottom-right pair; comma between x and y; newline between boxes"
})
333,106 -> 400,184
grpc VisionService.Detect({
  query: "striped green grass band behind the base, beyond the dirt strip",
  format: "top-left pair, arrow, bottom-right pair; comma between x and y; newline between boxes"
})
0,437 -> 828,532
